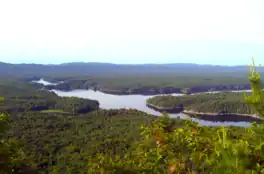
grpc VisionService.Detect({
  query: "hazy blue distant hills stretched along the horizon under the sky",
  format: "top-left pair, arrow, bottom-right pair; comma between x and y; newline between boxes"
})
0,62 -> 264,77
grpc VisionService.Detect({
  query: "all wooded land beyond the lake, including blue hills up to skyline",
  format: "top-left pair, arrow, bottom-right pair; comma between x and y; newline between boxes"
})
0,62 -> 264,95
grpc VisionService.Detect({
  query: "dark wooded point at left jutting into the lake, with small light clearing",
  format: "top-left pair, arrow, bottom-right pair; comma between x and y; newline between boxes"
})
0,83 -> 99,115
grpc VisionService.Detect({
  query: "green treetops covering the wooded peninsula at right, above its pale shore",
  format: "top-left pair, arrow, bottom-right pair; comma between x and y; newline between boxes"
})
147,92 -> 256,114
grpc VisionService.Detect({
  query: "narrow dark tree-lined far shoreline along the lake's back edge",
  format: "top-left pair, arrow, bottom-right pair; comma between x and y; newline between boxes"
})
31,78 -> 251,96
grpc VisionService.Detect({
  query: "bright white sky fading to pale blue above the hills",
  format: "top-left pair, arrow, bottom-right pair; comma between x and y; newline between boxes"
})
0,0 -> 264,65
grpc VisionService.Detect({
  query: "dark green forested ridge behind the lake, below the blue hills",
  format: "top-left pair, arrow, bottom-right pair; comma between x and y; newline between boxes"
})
43,75 -> 254,95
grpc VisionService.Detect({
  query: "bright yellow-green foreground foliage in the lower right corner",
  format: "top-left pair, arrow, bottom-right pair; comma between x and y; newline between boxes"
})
88,116 -> 264,174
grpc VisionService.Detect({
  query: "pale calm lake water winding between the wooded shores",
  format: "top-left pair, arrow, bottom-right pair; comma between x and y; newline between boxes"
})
36,79 -> 251,127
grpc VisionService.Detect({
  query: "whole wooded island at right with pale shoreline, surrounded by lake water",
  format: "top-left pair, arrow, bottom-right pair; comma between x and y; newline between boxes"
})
147,92 -> 261,122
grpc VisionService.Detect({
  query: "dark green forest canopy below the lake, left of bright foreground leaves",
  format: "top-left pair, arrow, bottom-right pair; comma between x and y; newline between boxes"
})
5,110 -> 162,173
